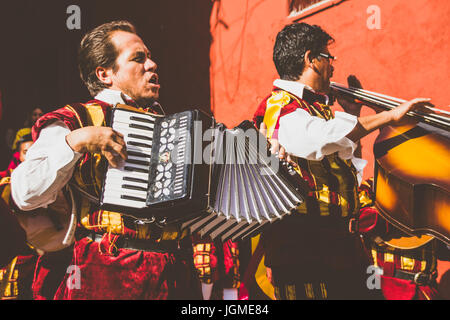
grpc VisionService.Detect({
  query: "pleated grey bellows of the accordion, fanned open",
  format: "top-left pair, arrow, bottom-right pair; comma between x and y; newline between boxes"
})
187,121 -> 303,241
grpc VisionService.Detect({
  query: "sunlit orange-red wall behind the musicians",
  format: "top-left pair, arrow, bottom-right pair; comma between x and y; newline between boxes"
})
210,0 -> 450,290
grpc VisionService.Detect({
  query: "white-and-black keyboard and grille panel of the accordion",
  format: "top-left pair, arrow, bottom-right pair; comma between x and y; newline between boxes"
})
102,108 -> 192,209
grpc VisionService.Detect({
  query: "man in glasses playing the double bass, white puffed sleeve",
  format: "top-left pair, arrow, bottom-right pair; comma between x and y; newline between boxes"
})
254,23 -> 430,299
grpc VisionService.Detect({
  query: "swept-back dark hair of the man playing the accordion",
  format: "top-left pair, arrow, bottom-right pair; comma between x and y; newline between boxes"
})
78,21 -> 136,97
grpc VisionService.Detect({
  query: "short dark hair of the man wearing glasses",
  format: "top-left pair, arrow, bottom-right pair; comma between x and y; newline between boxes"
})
273,23 -> 334,80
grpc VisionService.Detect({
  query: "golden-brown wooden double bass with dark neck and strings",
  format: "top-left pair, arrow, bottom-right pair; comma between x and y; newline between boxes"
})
330,83 -> 450,249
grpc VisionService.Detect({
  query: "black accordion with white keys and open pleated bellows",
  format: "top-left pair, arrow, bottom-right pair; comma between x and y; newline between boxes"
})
100,104 -> 306,241
